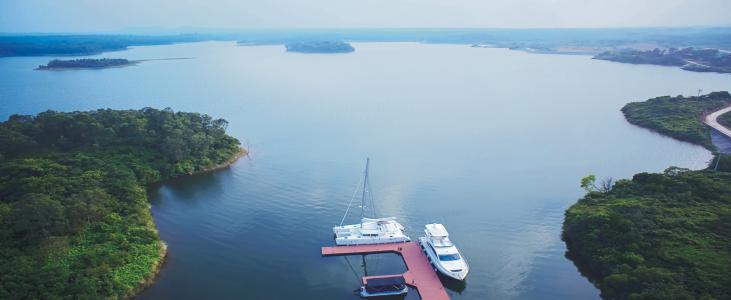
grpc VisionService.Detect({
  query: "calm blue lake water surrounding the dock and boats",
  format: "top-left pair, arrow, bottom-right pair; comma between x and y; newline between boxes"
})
0,42 -> 731,299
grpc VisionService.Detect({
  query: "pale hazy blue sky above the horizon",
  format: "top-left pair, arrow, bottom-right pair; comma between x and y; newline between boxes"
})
0,0 -> 731,32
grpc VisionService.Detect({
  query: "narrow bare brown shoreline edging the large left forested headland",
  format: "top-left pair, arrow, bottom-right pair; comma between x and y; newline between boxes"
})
127,147 -> 249,299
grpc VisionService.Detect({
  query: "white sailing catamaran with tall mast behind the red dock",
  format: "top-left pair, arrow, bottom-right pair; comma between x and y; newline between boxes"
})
333,159 -> 411,246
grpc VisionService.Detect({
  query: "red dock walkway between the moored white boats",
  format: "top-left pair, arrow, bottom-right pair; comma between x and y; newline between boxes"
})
322,242 -> 449,300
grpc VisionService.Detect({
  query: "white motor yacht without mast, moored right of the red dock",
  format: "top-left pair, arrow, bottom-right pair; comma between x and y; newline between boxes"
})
419,223 -> 470,280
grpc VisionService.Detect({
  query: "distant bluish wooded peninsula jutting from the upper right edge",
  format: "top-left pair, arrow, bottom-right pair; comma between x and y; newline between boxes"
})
594,47 -> 731,73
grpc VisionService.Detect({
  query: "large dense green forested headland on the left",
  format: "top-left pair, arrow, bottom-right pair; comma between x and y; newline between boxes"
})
0,108 -> 240,299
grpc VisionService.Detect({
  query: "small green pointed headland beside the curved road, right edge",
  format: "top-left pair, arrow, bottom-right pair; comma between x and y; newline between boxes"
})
622,92 -> 731,150
